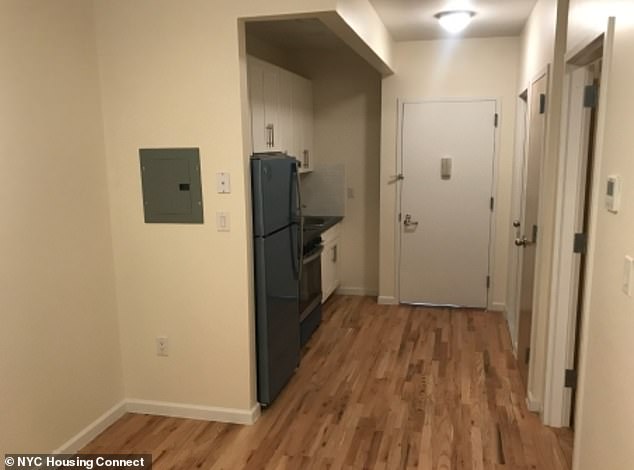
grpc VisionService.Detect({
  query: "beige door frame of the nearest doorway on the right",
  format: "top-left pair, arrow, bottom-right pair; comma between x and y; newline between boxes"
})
542,18 -> 614,430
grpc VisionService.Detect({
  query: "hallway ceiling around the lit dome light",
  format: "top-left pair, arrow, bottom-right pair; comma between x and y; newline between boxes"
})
370,0 -> 537,41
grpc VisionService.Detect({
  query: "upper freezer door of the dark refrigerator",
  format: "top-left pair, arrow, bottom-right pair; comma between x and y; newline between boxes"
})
251,155 -> 299,237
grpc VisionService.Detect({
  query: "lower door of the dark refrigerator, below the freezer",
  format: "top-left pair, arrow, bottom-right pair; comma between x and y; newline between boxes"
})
254,224 -> 300,405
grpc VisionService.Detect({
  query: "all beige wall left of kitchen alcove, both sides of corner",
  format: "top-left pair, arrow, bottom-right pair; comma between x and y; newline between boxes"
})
0,0 -> 389,453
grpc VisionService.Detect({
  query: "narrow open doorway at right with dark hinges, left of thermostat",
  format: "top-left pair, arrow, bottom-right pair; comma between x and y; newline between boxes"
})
544,31 -> 604,429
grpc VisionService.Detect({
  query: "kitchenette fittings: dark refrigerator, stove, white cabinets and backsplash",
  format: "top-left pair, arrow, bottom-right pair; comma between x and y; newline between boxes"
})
247,48 -> 345,406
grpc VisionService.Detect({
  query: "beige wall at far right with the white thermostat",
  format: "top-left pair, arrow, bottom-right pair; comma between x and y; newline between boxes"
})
569,0 -> 634,470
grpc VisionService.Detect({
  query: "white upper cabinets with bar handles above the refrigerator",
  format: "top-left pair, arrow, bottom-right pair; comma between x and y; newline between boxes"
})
247,57 -> 314,173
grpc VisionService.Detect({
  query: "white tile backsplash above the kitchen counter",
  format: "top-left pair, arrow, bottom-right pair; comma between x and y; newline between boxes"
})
301,164 -> 346,216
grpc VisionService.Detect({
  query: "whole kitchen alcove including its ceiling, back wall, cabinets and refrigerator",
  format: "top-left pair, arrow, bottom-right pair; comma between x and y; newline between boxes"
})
245,18 -> 381,407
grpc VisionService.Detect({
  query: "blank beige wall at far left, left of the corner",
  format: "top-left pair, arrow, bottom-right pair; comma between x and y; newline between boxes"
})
0,0 -> 124,455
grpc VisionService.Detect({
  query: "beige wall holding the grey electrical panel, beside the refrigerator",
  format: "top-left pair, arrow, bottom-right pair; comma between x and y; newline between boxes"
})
96,0 -> 390,412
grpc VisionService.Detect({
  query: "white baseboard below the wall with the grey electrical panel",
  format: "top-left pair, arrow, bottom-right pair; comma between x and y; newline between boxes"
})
126,399 -> 260,424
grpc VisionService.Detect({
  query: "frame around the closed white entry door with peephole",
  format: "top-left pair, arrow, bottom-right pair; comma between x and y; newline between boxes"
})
394,97 -> 504,310
